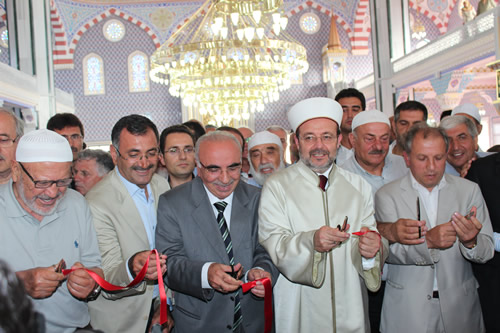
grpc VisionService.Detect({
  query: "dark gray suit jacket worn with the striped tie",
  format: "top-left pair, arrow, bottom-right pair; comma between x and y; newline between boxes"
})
156,177 -> 278,333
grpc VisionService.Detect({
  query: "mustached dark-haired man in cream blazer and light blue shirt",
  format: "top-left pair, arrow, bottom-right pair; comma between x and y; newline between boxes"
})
90,115 -> 172,333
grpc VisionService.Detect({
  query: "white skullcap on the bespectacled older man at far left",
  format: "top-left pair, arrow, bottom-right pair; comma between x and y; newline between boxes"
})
16,129 -> 73,163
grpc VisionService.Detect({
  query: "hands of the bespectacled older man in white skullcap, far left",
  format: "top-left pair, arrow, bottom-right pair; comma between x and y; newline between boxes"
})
16,262 -> 104,300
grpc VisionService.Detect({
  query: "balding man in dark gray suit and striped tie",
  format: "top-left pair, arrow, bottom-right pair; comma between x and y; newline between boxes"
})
156,131 -> 278,333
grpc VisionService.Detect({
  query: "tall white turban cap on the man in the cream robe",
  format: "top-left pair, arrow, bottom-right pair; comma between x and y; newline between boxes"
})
288,97 -> 343,132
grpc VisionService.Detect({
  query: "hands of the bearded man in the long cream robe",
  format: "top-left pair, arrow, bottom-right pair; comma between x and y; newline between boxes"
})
314,224 -> 380,259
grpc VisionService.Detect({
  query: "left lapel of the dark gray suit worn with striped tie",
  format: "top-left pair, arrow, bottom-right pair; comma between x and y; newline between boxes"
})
191,177 -> 232,263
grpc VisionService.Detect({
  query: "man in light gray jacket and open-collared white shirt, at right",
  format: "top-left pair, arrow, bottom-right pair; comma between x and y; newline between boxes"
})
375,123 -> 493,333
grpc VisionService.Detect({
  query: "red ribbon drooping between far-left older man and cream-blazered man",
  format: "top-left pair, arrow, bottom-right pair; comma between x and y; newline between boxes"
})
62,249 -> 168,326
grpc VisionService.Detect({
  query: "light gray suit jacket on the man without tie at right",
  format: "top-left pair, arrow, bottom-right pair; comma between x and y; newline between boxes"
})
375,173 -> 493,333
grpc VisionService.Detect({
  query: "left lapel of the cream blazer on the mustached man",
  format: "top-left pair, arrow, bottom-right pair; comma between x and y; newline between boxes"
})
111,171 -> 149,248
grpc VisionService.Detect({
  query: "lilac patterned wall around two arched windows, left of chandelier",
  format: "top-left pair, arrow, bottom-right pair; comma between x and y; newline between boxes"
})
55,16 -> 181,142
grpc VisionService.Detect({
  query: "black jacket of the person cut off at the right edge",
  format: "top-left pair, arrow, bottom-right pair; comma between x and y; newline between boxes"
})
466,153 -> 500,332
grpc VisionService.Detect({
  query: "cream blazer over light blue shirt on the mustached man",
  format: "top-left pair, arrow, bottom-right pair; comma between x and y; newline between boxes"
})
86,170 -> 170,333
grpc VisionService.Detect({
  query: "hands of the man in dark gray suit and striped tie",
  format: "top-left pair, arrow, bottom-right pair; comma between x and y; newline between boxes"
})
207,263 -> 271,297
